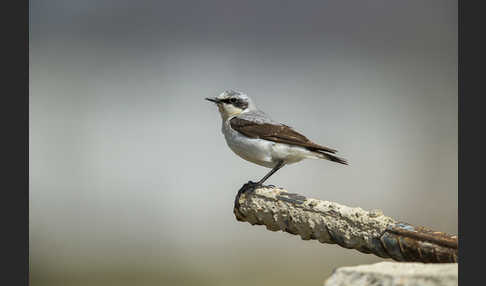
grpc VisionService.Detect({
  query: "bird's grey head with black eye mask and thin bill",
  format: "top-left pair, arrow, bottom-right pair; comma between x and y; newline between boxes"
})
206,90 -> 256,120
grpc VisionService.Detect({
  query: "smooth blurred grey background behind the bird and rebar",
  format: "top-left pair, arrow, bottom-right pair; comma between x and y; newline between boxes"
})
30,0 -> 458,286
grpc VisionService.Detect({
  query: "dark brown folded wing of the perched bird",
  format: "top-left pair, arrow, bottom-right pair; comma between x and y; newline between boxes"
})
230,117 -> 337,153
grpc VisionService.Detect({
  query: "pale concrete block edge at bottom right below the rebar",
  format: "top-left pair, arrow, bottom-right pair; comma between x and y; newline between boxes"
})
324,262 -> 458,286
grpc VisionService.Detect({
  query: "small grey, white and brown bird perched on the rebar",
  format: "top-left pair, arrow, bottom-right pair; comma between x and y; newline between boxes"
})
205,90 -> 348,194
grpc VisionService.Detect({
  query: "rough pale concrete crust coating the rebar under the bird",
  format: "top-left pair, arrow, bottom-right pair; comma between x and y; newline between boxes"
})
236,188 -> 396,249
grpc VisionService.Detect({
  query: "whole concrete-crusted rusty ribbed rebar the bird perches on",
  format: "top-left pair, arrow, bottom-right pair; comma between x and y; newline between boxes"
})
234,184 -> 458,263
